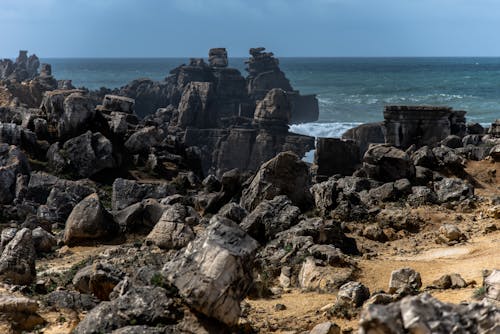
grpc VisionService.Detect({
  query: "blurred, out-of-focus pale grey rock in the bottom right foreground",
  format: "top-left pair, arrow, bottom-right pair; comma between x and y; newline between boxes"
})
359,293 -> 500,334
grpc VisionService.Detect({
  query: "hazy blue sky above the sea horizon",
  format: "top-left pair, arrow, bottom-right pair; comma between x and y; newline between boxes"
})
0,0 -> 500,57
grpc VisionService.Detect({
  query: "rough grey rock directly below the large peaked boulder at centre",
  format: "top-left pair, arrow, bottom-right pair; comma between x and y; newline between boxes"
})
240,196 -> 300,244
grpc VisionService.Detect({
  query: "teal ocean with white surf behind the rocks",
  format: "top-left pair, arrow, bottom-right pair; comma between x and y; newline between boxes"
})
42,58 -> 500,137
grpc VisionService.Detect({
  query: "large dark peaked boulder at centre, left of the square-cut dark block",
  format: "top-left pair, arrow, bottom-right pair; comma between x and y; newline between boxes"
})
241,152 -> 313,211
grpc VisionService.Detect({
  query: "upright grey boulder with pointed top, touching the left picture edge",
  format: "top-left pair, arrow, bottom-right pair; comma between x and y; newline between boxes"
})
0,228 -> 36,285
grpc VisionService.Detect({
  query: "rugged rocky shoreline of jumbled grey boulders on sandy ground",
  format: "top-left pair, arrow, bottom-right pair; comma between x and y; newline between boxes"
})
0,48 -> 500,334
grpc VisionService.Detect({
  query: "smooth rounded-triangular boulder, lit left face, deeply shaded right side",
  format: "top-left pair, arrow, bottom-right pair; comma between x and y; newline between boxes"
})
64,194 -> 119,245
